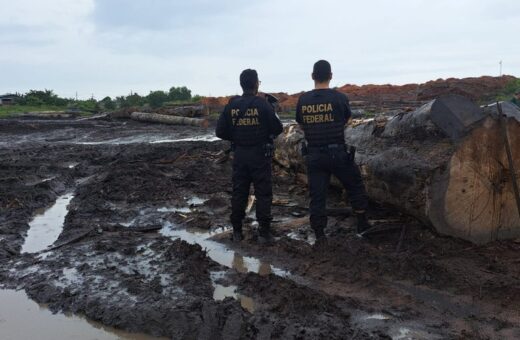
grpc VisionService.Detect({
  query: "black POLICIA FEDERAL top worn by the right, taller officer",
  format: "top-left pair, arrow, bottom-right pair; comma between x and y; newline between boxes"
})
296,89 -> 352,146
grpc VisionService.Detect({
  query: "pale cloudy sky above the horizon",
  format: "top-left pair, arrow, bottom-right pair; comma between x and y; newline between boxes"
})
0,0 -> 520,99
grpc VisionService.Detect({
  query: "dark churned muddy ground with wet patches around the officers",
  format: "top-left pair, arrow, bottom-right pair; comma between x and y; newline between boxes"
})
0,120 -> 520,339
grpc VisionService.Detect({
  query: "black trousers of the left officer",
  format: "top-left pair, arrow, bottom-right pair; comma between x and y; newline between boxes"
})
231,146 -> 273,227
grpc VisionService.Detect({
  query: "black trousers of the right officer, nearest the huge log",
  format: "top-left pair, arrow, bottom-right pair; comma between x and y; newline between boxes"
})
306,146 -> 368,234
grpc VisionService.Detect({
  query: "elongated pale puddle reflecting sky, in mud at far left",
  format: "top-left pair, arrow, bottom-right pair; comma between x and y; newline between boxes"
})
22,194 -> 74,253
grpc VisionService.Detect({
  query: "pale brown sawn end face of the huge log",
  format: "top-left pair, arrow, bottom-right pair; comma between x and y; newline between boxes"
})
428,118 -> 520,244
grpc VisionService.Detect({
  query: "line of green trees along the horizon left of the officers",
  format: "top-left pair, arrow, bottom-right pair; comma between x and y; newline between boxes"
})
9,86 -> 202,111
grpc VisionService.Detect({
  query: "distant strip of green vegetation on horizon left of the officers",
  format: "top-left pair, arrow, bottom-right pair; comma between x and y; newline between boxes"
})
0,86 -> 202,117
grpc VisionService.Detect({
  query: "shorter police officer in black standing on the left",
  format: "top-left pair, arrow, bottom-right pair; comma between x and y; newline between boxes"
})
215,69 -> 283,243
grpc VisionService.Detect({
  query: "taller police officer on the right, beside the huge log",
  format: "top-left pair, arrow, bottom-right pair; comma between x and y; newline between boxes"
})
296,60 -> 370,240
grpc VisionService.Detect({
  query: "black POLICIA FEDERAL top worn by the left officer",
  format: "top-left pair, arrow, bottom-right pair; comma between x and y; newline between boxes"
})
215,94 -> 283,146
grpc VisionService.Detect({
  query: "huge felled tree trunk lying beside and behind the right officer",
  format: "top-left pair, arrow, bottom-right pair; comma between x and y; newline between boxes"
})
276,96 -> 520,244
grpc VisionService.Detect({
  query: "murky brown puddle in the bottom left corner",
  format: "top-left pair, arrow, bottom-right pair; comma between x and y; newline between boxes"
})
0,290 -> 164,340
